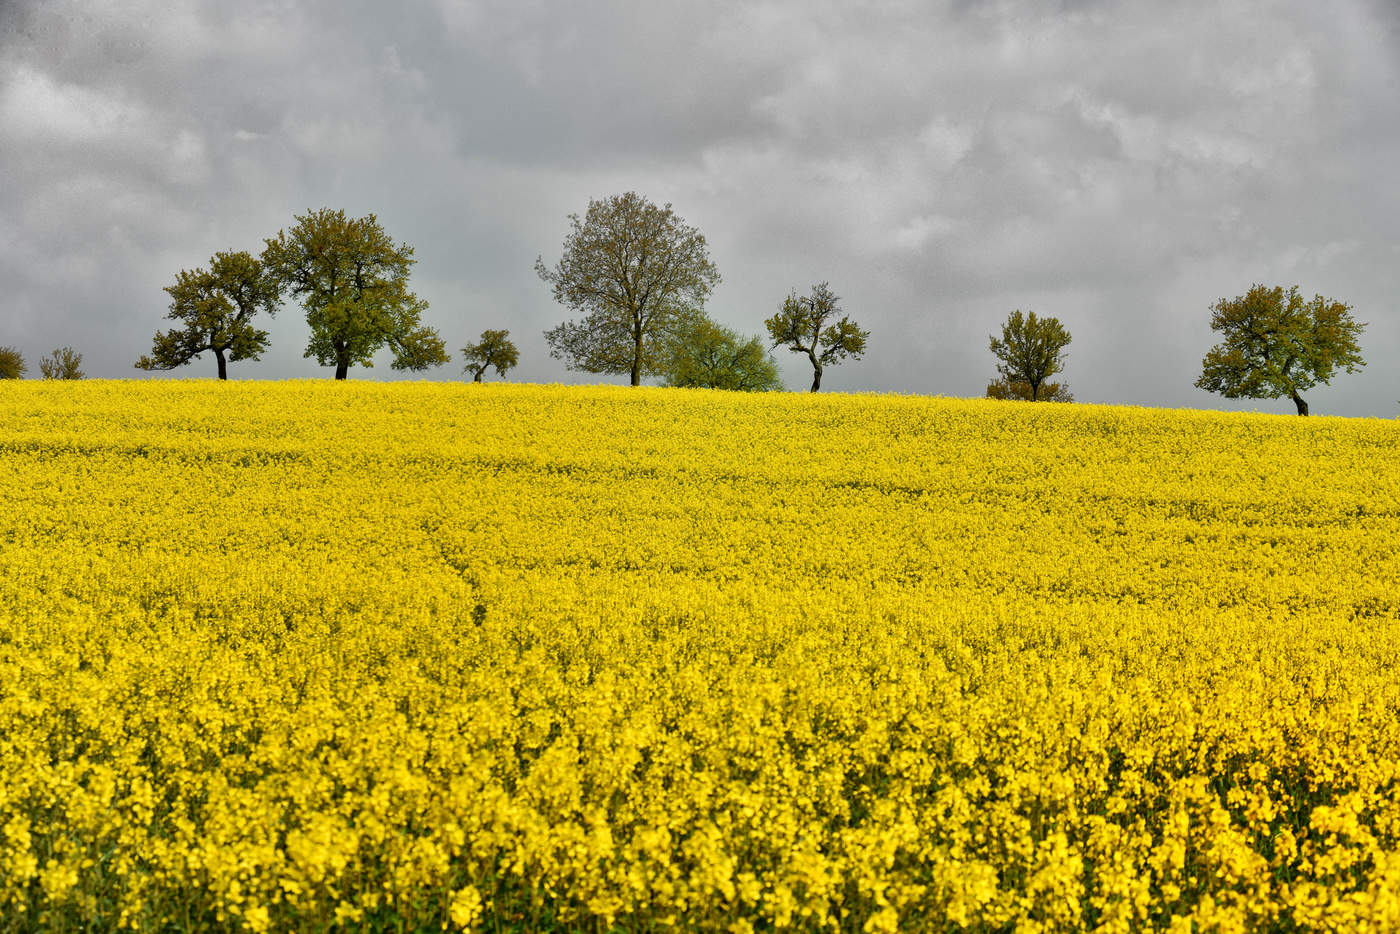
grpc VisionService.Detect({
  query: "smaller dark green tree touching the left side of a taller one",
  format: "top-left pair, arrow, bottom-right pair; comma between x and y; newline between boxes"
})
136,251 -> 280,379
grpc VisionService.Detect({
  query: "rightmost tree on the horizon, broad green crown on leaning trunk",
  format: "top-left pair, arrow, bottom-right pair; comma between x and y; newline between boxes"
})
1196,286 -> 1366,414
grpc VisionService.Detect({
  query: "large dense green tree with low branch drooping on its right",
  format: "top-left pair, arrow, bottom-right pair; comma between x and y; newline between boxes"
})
263,207 -> 449,379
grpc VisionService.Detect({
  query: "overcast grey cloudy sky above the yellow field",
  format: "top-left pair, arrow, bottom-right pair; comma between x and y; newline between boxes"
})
0,0 -> 1400,417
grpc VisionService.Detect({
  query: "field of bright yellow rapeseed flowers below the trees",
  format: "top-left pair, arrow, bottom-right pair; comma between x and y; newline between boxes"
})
0,381 -> 1400,931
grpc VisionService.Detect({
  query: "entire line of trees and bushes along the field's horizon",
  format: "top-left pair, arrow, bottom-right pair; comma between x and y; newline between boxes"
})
0,192 -> 1365,414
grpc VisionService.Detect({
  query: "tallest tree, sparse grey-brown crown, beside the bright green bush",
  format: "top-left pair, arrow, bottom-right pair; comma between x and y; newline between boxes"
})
535,192 -> 720,386
